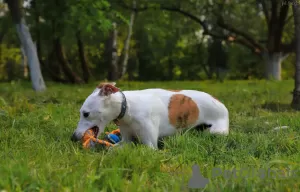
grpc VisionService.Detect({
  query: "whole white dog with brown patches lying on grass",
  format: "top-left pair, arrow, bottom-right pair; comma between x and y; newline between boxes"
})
72,83 -> 229,149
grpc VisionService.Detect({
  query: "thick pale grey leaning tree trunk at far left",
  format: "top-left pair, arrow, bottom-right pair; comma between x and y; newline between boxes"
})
7,0 -> 46,91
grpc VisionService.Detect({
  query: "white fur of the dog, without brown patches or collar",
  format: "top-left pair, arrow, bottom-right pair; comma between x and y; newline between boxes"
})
74,86 -> 229,149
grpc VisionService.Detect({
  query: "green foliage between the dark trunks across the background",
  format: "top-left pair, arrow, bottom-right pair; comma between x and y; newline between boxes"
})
0,0 -> 294,81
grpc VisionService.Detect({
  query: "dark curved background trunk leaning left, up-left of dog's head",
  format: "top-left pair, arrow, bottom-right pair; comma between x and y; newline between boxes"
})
54,37 -> 82,83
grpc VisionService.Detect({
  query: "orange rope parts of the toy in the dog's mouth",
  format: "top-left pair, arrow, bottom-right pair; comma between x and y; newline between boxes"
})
82,128 -> 120,148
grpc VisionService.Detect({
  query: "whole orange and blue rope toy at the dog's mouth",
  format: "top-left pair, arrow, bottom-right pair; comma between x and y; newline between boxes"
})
82,128 -> 121,149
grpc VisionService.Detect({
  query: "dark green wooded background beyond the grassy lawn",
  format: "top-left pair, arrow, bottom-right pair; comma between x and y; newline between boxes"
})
0,0 -> 295,83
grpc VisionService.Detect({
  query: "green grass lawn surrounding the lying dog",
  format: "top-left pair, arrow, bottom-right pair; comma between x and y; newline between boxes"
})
0,81 -> 300,192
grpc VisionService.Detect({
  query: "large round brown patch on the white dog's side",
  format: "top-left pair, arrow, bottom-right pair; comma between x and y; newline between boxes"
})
168,94 -> 200,129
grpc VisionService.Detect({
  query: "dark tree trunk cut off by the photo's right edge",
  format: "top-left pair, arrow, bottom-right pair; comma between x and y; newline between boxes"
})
291,1 -> 300,110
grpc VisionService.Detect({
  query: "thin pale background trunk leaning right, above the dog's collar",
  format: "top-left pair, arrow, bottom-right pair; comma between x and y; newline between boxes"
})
121,1 -> 136,78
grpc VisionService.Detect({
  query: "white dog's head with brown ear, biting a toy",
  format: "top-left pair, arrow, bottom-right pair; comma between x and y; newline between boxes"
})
71,82 -> 120,141
